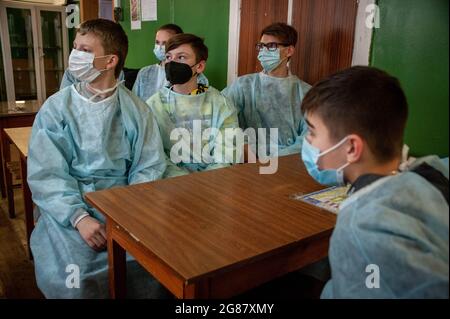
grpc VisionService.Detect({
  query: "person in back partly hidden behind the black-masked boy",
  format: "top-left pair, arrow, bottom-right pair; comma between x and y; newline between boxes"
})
133,24 -> 183,102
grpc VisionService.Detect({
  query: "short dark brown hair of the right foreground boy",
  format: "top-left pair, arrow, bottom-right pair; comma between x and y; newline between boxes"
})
302,66 -> 408,163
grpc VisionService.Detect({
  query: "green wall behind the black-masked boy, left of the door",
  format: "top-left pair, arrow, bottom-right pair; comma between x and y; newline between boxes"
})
121,0 -> 229,90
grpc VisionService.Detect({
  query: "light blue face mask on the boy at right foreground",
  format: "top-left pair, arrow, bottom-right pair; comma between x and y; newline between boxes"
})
302,136 -> 350,186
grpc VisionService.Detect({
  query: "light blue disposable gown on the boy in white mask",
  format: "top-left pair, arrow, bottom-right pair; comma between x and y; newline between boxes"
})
28,85 -> 166,298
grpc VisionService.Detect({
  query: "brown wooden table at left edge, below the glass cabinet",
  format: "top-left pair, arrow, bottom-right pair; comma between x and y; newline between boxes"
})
0,101 -> 41,204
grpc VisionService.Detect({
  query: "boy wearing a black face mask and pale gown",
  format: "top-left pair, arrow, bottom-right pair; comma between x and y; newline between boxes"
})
147,34 -> 238,177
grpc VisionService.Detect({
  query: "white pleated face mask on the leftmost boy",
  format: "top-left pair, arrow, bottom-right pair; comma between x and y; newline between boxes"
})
69,49 -> 110,83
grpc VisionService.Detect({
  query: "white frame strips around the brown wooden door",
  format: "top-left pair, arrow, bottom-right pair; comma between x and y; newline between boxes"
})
227,0 -> 375,85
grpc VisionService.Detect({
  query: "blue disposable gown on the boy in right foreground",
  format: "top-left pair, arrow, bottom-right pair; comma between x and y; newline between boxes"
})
321,156 -> 449,298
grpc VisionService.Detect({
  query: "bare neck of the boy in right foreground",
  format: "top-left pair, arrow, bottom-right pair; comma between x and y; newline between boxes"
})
346,158 -> 401,184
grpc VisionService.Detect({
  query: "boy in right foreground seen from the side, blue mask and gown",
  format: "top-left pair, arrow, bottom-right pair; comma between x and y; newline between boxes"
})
301,67 -> 449,298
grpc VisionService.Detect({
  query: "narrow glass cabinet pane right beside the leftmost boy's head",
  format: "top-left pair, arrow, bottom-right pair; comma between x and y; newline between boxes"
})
41,11 -> 64,97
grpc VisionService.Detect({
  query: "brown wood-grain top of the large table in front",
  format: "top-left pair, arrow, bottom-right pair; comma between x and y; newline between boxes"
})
86,155 -> 336,283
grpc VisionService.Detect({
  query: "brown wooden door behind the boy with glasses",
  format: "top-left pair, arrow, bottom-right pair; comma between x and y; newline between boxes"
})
238,0 -> 358,84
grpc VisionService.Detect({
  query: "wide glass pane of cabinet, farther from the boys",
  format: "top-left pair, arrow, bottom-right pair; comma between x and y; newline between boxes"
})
6,8 -> 37,100
